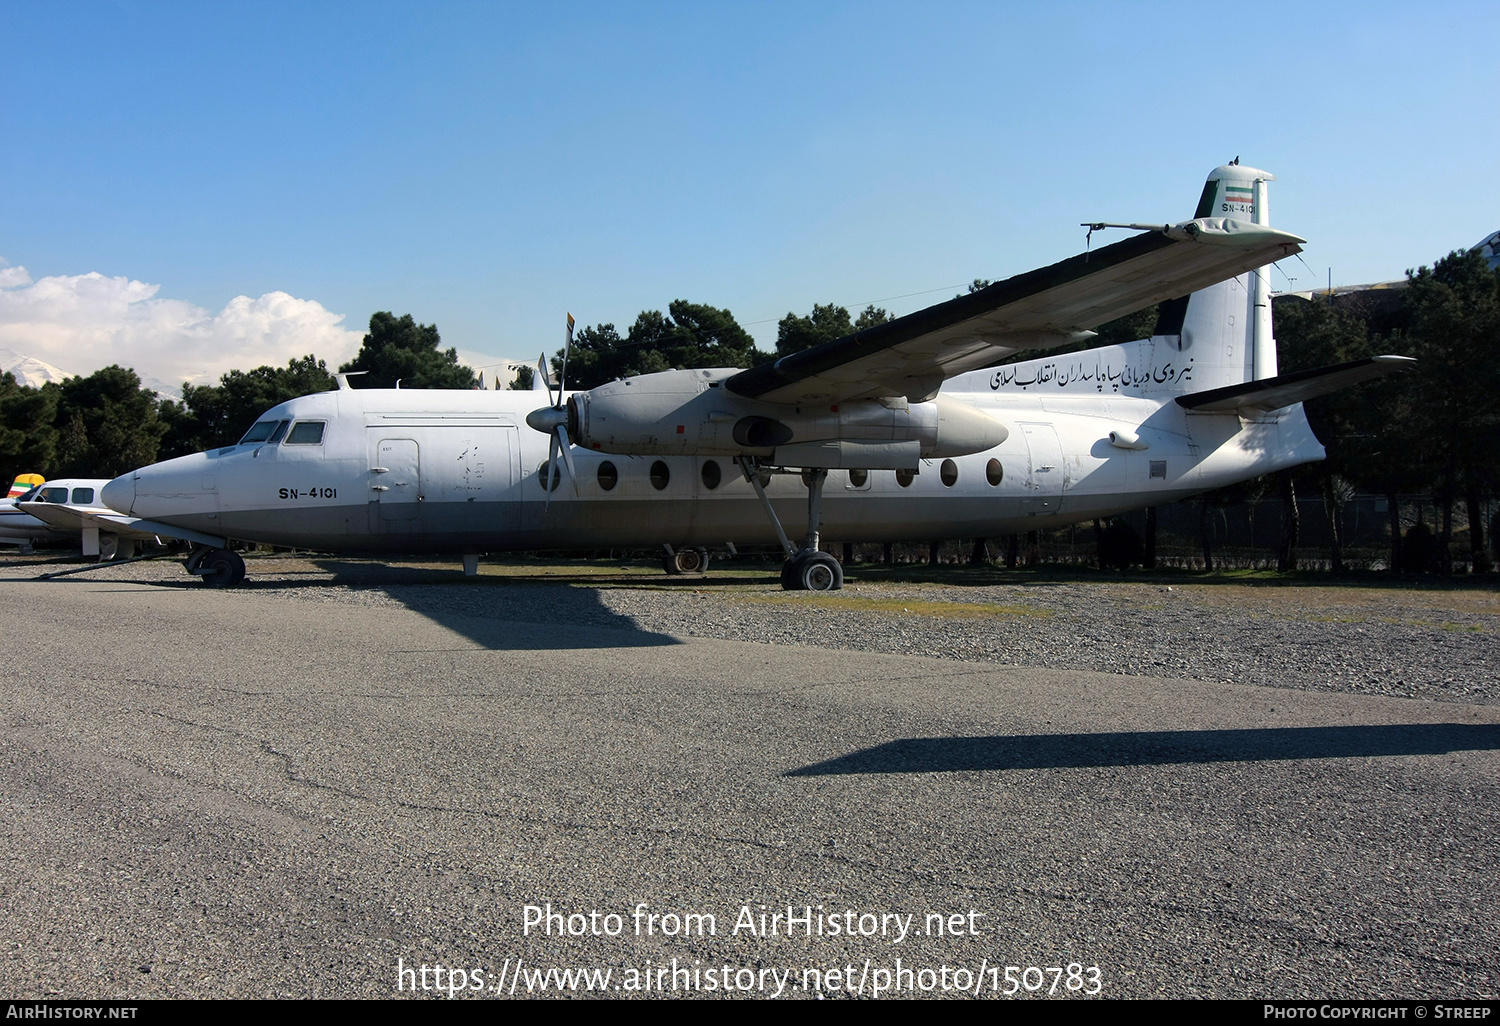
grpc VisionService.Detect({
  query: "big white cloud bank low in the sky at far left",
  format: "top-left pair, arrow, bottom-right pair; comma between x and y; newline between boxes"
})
0,267 -> 363,384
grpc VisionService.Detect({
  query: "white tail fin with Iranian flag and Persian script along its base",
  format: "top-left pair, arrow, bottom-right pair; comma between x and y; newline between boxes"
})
975,164 -> 1277,396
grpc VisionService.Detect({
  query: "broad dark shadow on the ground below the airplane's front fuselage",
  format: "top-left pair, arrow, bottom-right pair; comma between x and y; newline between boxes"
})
306,560 -> 681,651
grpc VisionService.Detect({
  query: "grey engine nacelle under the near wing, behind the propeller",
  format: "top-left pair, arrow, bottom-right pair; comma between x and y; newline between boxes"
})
569,368 -> 1010,470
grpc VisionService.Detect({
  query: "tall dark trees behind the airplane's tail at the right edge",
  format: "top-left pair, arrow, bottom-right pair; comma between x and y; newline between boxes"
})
1274,251 -> 1500,573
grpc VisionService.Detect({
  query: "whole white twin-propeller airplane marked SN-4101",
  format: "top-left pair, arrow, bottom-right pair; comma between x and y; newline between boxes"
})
104,164 -> 1410,591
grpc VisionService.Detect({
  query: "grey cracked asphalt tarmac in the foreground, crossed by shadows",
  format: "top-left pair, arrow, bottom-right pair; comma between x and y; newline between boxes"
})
0,564 -> 1500,999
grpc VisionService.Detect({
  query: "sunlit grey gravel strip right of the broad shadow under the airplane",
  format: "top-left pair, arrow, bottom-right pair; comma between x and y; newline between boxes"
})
605,584 -> 1500,704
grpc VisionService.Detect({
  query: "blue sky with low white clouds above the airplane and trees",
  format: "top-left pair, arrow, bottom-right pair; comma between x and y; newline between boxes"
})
0,0 -> 1500,381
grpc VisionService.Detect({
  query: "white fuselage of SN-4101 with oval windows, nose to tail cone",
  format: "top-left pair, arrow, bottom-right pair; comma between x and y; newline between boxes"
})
105,375 -> 1323,552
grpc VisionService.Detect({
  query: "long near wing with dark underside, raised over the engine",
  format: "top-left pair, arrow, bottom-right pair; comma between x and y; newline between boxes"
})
725,218 -> 1305,405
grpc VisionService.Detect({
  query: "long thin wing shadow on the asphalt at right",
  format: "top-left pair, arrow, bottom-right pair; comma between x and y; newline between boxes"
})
785,723 -> 1500,777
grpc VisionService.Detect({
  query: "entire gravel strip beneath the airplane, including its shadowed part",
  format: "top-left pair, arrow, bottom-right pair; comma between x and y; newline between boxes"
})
0,555 -> 1500,704
